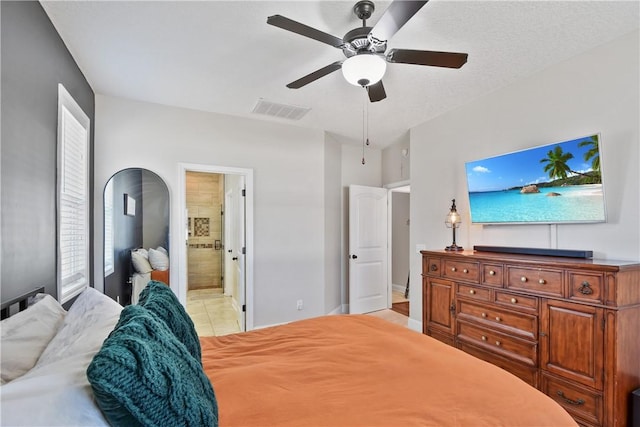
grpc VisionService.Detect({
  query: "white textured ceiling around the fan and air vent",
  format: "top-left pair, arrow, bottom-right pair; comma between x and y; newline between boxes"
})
41,0 -> 640,147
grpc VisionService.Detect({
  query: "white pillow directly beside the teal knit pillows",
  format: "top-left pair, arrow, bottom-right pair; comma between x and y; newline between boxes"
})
34,288 -> 122,370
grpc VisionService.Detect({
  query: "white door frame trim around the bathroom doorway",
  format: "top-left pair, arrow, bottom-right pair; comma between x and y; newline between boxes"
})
178,163 -> 255,331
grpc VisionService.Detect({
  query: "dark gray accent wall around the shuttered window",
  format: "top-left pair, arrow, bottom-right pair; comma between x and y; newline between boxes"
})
0,0 -> 95,300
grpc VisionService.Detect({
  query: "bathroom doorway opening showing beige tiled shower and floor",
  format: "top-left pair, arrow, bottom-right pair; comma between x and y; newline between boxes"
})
180,165 -> 252,336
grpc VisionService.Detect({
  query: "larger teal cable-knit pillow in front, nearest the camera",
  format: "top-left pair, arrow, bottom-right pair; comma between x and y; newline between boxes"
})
87,306 -> 218,426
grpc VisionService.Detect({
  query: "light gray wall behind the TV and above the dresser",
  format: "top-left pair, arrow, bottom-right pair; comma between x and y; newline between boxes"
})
410,31 -> 640,328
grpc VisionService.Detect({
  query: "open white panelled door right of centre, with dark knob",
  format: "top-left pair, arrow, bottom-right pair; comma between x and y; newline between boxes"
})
349,185 -> 389,314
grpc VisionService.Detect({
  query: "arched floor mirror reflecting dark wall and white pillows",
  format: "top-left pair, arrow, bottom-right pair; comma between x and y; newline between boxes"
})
103,168 -> 170,305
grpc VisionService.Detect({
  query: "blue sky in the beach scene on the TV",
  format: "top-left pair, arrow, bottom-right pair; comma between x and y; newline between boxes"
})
465,136 -> 591,193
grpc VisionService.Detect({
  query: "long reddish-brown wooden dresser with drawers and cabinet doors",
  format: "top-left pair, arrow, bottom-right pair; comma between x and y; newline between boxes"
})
422,251 -> 640,427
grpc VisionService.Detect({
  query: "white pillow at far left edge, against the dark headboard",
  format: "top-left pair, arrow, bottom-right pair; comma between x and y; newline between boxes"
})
0,294 -> 66,384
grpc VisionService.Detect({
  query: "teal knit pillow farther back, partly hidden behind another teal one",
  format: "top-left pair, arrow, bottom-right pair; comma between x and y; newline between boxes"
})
138,280 -> 202,363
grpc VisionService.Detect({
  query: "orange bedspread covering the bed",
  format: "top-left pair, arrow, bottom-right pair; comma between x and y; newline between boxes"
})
201,315 -> 576,427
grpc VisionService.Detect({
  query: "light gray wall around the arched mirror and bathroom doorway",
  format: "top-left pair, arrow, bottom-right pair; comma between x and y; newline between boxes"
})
94,95 -> 332,327
